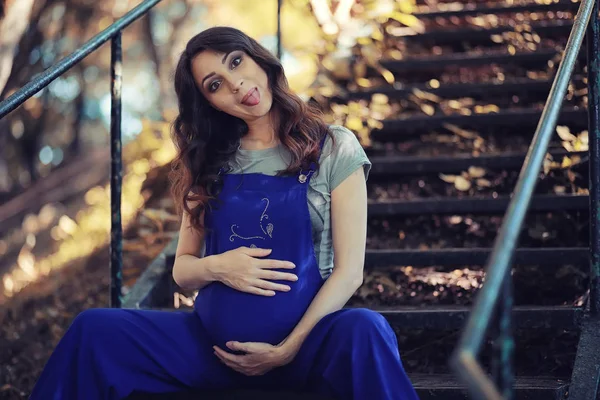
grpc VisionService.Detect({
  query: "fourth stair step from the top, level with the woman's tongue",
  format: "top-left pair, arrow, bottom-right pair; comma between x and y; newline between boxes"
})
332,76 -> 583,103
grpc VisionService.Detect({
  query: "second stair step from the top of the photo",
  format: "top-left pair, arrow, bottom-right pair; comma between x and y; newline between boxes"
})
396,20 -> 573,45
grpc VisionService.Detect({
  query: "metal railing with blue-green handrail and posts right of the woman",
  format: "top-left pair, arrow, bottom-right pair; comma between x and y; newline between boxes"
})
450,0 -> 600,400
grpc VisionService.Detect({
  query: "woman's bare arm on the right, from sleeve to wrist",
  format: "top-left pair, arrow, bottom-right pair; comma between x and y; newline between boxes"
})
281,166 -> 367,358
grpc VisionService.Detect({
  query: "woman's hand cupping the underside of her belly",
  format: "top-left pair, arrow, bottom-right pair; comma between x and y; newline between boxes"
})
213,342 -> 295,376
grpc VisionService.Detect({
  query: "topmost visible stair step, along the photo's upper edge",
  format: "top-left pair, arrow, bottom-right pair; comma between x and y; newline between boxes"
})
413,0 -> 579,19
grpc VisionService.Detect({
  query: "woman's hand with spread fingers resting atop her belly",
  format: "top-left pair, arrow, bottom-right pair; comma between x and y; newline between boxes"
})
217,247 -> 298,296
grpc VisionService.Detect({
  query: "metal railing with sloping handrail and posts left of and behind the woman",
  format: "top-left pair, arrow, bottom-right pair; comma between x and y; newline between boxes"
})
0,0 -> 283,308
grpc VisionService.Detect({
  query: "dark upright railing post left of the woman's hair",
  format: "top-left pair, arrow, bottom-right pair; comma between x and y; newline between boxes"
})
109,31 -> 123,308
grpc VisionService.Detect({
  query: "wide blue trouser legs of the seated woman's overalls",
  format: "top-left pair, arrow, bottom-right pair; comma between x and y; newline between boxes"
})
30,308 -> 417,400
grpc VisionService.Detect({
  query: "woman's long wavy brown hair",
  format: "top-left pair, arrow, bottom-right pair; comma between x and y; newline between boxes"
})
170,27 -> 333,232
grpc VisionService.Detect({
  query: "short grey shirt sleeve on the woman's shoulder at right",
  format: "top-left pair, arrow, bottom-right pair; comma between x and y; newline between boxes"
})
320,125 -> 371,192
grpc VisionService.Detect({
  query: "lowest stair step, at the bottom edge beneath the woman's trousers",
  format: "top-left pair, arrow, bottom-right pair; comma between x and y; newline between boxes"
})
128,374 -> 569,400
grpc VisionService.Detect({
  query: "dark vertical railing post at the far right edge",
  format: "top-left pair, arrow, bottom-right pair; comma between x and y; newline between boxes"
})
587,0 -> 600,315
